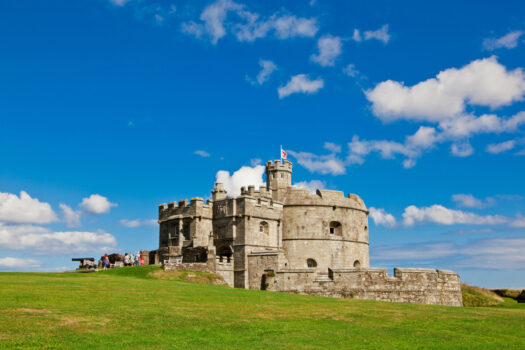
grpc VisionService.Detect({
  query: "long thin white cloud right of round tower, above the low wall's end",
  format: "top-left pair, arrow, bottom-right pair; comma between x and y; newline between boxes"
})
403,204 -> 508,226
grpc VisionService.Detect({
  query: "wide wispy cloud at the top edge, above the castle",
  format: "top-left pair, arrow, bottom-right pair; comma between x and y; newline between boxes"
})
182,0 -> 319,44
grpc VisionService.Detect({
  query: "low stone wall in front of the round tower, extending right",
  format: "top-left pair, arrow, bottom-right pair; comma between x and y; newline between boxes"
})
266,268 -> 463,306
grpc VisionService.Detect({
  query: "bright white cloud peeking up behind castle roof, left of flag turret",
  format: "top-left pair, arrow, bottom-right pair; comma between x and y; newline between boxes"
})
215,165 -> 265,196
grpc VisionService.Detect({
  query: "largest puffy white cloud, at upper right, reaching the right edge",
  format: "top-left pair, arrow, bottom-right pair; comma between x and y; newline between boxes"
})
365,56 -> 525,122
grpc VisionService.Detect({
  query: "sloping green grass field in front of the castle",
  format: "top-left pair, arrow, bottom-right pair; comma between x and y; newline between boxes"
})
0,266 -> 525,349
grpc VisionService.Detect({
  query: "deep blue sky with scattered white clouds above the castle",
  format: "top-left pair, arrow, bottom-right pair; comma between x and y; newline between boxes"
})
0,0 -> 525,288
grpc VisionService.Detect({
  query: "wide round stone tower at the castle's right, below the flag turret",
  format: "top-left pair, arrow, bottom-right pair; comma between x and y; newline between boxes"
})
282,188 -> 370,272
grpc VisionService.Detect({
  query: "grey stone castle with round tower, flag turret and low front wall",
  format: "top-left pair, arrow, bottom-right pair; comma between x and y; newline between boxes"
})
150,160 -> 462,306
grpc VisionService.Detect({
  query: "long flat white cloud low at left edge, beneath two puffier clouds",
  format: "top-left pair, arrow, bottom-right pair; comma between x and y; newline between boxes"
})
0,223 -> 117,255
